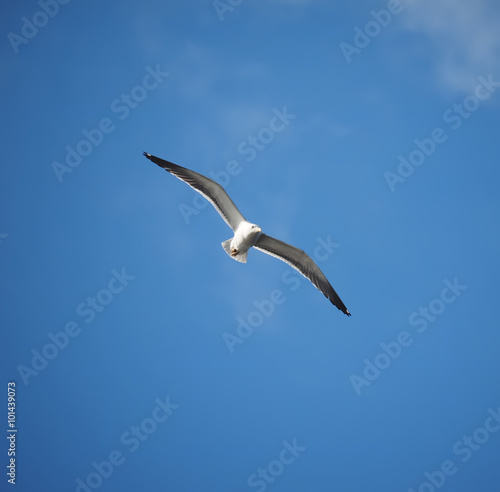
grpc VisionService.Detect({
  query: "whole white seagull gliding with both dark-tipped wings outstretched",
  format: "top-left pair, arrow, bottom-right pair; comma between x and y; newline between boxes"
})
144,152 -> 351,316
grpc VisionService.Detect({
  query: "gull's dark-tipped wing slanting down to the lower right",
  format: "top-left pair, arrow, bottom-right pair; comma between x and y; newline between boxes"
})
254,234 -> 351,316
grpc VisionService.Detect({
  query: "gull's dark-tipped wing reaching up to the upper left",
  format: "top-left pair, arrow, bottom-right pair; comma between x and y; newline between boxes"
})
144,152 -> 245,231
